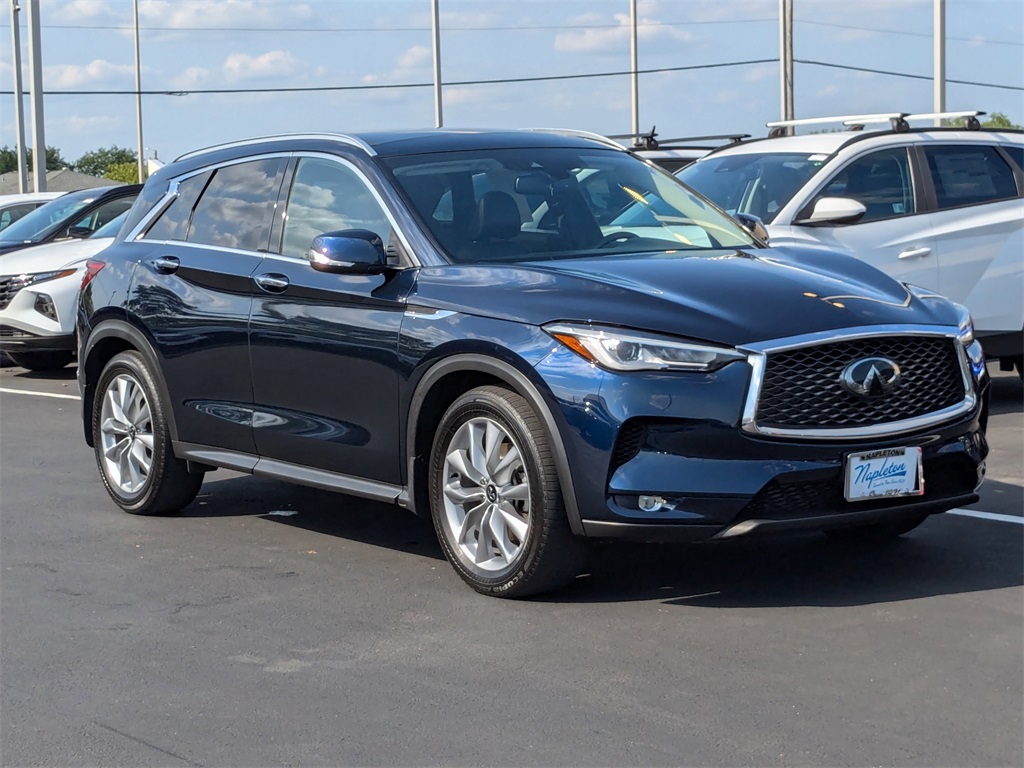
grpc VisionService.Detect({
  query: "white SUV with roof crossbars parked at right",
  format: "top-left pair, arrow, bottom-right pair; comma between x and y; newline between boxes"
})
679,113 -> 1024,372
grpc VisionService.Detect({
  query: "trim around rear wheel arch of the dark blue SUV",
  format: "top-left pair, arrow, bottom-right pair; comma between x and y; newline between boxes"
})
79,319 -> 178,447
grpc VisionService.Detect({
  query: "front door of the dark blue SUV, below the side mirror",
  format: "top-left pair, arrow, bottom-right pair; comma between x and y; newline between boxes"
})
250,157 -> 409,484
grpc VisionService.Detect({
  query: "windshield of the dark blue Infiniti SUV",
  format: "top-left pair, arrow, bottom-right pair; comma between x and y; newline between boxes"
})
384,148 -> 754,263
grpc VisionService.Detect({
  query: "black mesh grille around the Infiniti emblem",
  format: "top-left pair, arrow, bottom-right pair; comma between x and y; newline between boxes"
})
757,336 -> 966,429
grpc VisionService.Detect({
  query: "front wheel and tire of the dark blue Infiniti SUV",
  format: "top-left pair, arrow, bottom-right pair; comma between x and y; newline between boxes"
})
429,386 -> 585,597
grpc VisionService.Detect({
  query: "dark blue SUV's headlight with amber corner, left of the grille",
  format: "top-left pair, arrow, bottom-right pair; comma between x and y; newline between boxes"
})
544,323 -> 746,371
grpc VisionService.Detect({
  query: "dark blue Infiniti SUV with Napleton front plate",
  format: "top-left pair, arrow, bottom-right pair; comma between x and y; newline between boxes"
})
78,130 -> 988,597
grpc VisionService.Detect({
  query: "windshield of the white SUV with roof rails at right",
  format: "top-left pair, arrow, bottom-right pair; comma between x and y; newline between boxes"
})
677,153 -> 826,224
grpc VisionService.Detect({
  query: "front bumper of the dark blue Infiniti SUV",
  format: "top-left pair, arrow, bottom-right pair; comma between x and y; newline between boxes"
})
538,339 -> 988,542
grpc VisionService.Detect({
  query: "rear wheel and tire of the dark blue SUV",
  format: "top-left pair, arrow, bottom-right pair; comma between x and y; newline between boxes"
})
92,350 -> 203,515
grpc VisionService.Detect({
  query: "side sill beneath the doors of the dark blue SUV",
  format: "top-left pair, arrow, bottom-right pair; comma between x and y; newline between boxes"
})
173,442 -> 404,504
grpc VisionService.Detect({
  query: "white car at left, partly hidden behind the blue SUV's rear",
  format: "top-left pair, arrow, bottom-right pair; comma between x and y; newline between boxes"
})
0,211 -> 128,371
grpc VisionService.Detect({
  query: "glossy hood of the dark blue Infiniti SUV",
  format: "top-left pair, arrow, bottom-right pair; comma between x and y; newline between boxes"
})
409,248 -> 956,346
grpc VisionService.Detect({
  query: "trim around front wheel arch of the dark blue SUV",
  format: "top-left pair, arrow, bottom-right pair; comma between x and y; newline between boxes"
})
398,353 -> 586,536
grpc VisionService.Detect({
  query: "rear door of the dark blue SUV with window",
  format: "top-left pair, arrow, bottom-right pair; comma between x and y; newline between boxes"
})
128,156 -> 288,454
